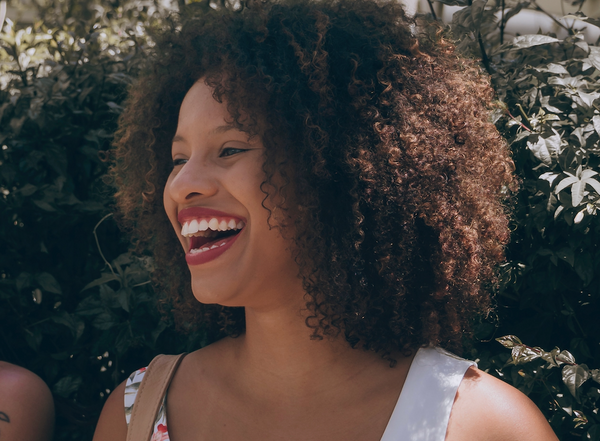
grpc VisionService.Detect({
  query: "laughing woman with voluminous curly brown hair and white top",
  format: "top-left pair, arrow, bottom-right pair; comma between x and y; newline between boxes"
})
94,0 -> 556,441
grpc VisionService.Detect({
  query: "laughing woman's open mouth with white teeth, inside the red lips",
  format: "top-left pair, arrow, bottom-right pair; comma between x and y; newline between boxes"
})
181,217 -> 245,255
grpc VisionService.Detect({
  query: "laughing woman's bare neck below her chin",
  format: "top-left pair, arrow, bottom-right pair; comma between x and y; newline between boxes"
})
230,296 -> 387,397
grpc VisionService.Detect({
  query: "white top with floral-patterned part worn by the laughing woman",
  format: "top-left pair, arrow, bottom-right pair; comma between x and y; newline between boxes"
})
125,348 -> 476,441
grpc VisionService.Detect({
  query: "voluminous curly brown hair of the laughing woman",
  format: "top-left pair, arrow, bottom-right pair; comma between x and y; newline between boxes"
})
112,0 -> 514,356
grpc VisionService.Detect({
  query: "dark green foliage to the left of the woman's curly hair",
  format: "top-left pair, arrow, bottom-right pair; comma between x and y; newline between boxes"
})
0,1 -> 205,440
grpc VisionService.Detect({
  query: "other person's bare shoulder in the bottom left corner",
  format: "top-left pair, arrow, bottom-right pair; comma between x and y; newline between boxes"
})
0,361 -> 54,441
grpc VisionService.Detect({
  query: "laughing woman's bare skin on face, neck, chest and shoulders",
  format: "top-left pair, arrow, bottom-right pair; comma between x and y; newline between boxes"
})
94,81 -> 557,441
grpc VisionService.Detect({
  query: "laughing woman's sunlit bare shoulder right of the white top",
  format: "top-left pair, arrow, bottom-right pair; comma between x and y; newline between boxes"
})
446,367 -> 558,441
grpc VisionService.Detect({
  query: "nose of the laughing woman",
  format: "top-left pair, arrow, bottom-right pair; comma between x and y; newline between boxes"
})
165,156 -> 218,204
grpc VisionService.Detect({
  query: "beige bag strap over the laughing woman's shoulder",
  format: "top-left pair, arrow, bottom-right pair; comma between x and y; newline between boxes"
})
127,353 -> 186,441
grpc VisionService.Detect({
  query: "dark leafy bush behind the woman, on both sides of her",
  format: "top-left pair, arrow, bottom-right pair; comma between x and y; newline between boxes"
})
0,0 -> 600,441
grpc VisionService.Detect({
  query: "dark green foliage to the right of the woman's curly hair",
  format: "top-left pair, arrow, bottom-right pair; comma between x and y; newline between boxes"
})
426,0 -> 600,441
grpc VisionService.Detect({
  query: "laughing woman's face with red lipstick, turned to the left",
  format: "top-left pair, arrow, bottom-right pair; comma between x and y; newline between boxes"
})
164,80 -> 301,308
